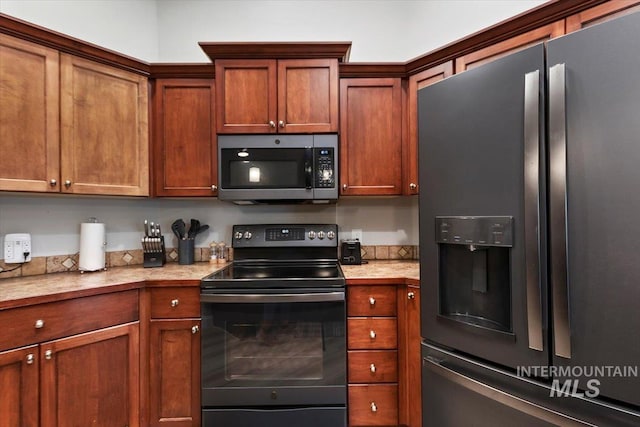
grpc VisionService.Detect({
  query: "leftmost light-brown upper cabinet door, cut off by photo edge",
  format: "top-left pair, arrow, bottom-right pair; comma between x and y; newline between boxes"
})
0,34 -> 60,192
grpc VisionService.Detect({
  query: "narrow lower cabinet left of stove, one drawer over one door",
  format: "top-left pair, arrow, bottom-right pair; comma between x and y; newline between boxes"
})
148,286 -> 201,427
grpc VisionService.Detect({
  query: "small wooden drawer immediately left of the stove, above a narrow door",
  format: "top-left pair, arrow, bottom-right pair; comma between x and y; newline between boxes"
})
151,286 -> 200,319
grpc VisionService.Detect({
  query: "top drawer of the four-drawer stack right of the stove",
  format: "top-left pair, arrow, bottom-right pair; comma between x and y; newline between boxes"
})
347,285 -> 396,316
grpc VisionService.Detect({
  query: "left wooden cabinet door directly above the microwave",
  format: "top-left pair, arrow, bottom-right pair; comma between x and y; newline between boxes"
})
215,59 -> 278,133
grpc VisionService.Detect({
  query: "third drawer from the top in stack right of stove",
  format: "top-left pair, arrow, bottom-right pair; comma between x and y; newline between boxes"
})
347,350 -> 398,383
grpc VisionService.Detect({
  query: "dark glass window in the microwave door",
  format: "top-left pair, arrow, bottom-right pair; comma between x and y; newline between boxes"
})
221,148 -> 313,189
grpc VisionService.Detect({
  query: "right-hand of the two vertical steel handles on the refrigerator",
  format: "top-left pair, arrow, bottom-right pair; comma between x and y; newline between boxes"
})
549,64 -> 571,359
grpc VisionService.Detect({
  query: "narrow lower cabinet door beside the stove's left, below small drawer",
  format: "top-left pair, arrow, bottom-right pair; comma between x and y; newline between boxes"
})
149,319 -> 200,427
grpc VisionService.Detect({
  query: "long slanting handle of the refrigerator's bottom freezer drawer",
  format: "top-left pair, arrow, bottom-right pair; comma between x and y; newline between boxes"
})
422,356 -> 596,427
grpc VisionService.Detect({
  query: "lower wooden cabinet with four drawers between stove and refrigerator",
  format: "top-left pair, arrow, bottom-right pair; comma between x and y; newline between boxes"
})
347,280 -> 422,427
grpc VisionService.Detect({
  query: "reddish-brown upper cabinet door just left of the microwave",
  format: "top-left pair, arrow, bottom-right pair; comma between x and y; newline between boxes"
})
153,79 -> 218,196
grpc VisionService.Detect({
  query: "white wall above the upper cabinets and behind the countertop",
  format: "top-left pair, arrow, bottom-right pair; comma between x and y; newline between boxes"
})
0,0 -> 542,257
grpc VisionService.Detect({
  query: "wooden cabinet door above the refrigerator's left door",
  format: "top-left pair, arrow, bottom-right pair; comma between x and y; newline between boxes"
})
455,20 -> 565,73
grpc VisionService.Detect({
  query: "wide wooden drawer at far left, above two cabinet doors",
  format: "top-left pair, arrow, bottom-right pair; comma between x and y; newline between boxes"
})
0,290 -> 138,349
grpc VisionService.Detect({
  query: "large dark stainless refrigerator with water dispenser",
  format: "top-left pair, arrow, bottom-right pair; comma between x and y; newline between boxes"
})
418,13 -> 640,427
